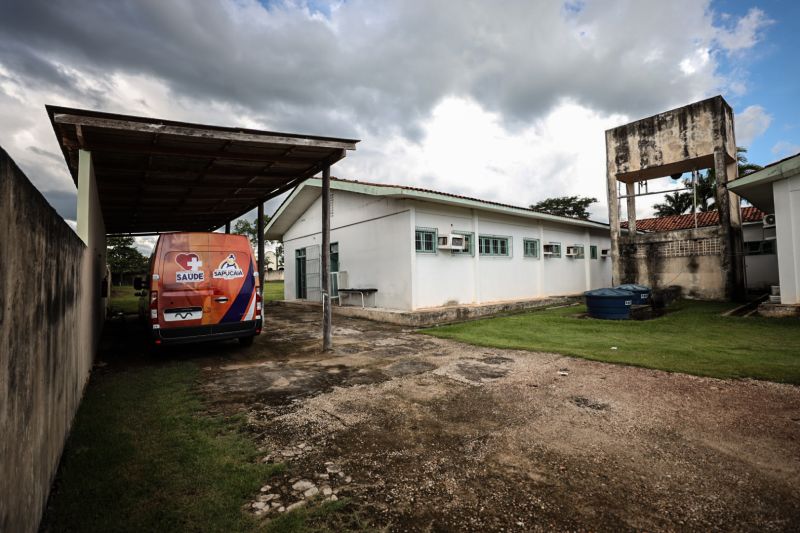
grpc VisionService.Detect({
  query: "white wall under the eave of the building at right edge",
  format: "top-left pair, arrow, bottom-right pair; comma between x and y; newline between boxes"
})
772,176 -> 800,304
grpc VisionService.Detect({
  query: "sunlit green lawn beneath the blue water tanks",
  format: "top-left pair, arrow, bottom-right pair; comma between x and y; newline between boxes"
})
423,301 -> 800,384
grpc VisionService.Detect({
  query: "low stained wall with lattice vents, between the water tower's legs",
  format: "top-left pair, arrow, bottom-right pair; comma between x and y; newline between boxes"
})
619,227 -> 725,300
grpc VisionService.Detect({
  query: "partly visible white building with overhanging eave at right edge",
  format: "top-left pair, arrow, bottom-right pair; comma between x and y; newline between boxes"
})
728,154 -> 800,306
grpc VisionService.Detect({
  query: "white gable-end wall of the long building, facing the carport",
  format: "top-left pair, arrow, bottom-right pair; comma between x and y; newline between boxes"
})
283,191 -> 413,309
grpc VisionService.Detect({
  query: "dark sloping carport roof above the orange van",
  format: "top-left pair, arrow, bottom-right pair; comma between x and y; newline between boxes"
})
46,106 -> 358,234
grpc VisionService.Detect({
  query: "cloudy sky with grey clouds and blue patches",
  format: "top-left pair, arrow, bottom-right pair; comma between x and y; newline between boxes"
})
0,0 -> 800,249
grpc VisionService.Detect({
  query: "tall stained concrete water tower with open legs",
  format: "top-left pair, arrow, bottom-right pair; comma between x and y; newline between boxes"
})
606,96 -> 745,299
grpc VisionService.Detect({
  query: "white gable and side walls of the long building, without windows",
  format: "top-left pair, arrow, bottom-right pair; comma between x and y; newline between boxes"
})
284,191 -> 611,310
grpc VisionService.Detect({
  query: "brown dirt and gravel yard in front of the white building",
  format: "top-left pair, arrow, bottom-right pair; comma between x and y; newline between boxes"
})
180,306 -> 800,531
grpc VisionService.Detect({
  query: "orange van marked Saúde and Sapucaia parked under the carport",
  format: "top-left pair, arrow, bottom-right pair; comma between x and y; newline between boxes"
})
149,233 -> 262,344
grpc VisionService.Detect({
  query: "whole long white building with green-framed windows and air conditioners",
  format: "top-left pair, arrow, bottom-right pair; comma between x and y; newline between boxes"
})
266,179 -> 611,311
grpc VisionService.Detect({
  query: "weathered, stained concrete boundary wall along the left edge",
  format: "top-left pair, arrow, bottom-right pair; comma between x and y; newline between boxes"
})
0,149 -> 104,532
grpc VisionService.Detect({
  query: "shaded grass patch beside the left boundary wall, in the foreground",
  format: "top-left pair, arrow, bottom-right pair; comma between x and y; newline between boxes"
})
45,362 -> 282,532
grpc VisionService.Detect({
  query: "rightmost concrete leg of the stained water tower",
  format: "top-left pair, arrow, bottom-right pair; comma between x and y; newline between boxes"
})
714,149 -> 746,300
